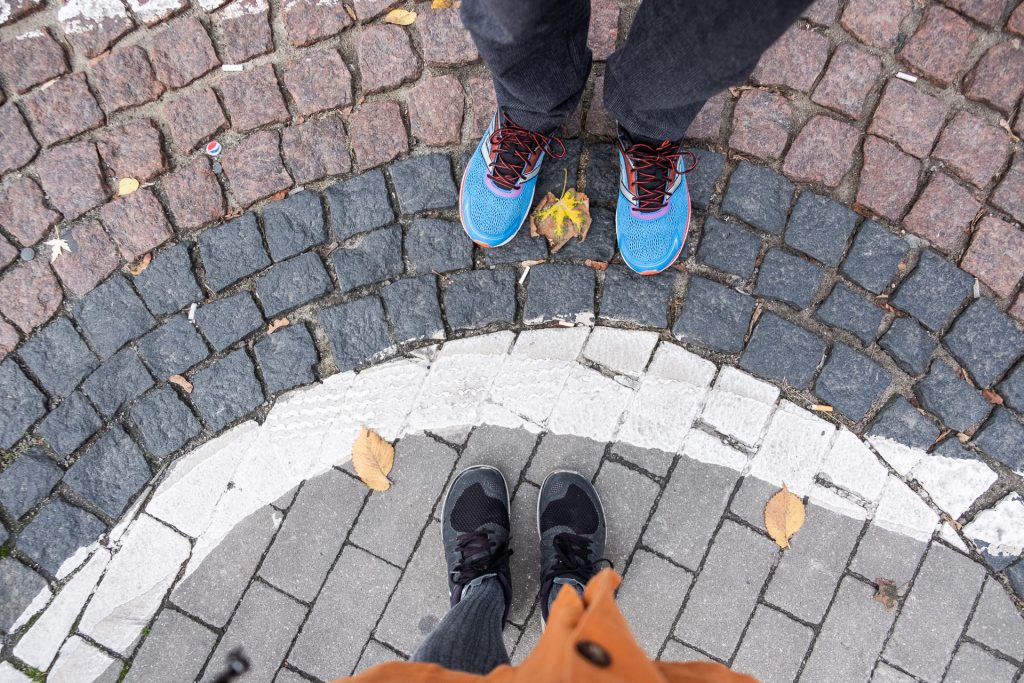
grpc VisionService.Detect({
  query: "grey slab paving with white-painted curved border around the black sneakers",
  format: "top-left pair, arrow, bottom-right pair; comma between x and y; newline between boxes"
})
6,328 -> 1024,683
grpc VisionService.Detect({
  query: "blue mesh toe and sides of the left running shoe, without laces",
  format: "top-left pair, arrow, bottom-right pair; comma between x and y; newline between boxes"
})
459,133 -> 540,247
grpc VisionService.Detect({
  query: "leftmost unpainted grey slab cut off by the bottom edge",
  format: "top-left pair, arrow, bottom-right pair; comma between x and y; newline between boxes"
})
124,608 -> 217,683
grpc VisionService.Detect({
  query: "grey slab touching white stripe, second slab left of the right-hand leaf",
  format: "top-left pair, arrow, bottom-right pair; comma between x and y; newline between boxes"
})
643,458 -> 739,571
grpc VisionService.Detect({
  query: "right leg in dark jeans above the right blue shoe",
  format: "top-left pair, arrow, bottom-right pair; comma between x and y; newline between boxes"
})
604,0 -> 811,140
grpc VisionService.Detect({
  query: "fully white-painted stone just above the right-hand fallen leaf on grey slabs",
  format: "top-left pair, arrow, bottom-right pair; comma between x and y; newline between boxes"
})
750,400 -> 836,496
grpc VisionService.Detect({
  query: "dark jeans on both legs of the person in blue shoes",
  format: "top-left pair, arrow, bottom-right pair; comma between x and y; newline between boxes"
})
462,0 -> 811,140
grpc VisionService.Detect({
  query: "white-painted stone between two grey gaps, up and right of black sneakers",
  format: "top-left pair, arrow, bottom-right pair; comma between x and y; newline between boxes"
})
616,376 -> 707,453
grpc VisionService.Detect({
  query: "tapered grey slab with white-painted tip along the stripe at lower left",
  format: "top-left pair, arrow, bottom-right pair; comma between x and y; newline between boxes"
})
171,507 -> 281,628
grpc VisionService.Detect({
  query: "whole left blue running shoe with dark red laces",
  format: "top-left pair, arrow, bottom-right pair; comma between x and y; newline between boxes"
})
459,110 -> 565,247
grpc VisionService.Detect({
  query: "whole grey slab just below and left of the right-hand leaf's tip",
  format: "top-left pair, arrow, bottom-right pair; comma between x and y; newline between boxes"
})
675,521 -> 778,659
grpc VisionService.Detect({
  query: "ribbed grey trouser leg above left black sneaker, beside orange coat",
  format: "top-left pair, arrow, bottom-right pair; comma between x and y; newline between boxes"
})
413,579 -> 509,675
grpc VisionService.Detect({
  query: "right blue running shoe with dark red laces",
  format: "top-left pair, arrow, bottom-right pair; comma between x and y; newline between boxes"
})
615,126 -> 697,275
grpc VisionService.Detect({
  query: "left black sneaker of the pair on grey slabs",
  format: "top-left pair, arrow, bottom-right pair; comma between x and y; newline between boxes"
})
441,465 -> 512,624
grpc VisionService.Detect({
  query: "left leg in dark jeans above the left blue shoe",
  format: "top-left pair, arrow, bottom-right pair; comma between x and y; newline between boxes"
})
461,0 -> 591,133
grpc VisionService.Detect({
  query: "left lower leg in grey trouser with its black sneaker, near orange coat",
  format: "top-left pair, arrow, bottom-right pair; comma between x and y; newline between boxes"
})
413,465 -> 512,675
